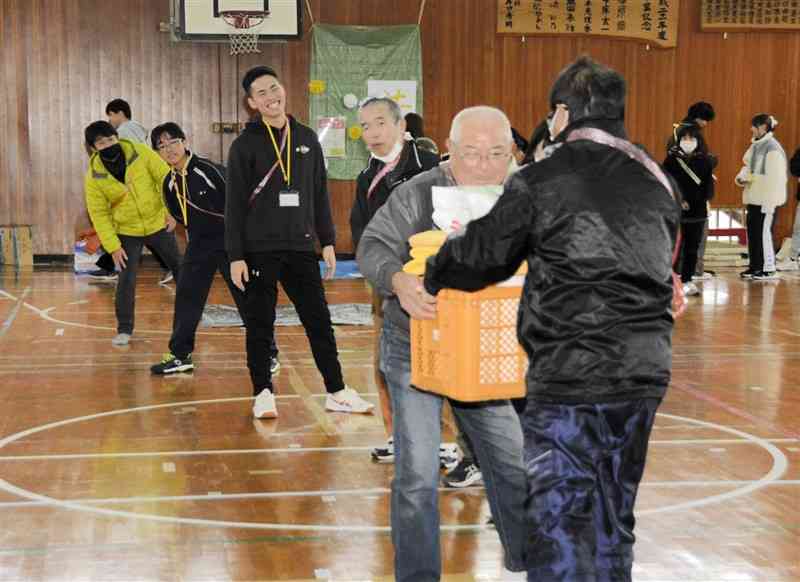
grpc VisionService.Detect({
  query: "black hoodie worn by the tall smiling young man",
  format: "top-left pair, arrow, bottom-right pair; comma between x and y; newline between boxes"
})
225,116 -> 336,261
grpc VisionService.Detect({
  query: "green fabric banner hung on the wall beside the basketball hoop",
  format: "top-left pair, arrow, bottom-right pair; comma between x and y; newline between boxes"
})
308,24 -> 422,180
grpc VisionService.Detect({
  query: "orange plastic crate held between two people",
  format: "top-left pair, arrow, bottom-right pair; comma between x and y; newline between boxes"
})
411,286 -> 528,402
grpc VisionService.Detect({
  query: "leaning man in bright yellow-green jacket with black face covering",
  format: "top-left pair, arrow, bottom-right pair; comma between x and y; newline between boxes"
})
84,121 -> 180,346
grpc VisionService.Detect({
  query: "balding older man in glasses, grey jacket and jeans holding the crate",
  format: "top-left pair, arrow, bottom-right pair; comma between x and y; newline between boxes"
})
357,106 -> 526,582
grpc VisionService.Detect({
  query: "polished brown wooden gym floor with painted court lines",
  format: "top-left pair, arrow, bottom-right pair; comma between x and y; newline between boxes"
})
0,269 -> 800,582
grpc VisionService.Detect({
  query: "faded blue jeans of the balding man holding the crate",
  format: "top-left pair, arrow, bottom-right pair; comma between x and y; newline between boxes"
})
380,320 -> 526,582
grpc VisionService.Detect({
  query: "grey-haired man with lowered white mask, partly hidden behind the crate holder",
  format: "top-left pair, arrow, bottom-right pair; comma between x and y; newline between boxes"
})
350,97 -> 439,463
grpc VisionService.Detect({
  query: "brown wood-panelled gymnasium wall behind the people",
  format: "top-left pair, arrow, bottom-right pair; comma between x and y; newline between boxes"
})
0,0 -> 800,254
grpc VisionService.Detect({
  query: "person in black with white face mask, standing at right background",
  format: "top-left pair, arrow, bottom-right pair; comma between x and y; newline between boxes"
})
664,123 -> 714,295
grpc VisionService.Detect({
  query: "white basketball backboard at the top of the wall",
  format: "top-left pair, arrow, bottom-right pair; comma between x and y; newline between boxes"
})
171,0 -> 303,42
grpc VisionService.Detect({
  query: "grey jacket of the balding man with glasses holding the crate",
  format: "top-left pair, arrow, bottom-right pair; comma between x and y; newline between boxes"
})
356,162 -> 456,338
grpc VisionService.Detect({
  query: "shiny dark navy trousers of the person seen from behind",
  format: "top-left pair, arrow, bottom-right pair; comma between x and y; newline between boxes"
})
523,398 -> 661,582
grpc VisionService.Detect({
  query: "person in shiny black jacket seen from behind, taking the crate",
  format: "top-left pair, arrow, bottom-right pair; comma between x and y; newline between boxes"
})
425,57 -> 680,582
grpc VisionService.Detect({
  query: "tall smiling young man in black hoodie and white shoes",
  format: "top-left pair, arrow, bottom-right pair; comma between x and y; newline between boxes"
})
225,66 -> 374,418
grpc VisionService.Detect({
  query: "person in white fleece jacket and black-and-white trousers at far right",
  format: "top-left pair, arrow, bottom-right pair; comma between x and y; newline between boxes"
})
736,113 -> 788,280
